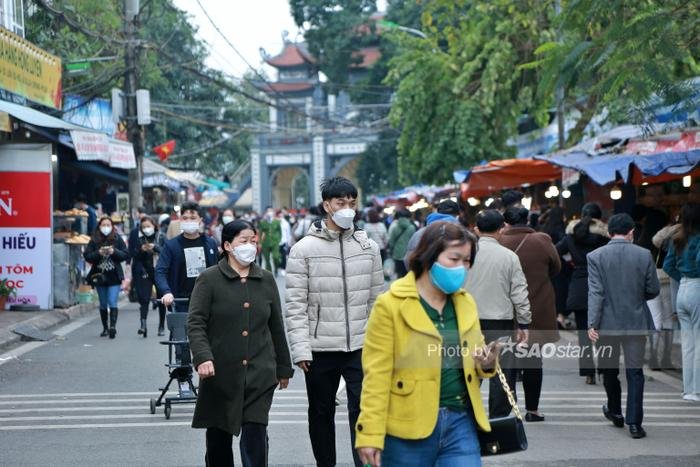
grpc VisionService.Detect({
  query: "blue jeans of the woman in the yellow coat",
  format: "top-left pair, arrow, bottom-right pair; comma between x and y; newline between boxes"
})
382,407 -> 481,467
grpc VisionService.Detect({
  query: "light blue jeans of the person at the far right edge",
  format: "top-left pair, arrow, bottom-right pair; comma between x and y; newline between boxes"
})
676,277 -> 700,395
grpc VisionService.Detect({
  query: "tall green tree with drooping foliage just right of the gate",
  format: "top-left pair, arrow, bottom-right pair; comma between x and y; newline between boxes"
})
385,0 -> 553,183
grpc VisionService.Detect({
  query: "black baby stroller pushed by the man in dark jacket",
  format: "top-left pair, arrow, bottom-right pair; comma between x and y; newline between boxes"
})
151,298 -> 197,420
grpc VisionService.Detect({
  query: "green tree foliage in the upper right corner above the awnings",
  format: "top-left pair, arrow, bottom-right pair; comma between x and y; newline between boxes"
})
526,0 -> 700,146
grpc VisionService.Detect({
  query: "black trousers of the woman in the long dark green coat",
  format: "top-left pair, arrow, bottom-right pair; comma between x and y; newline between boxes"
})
205,423 -> 268,467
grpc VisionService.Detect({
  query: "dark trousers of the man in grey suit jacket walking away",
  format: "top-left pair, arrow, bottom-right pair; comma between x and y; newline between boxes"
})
597,336 -> 646,425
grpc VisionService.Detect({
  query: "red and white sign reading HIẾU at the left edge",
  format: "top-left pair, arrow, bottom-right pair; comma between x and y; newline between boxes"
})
0,172 -> 52,309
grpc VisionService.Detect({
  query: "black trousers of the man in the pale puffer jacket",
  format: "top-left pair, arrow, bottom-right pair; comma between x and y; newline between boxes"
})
304,350 -> 362,467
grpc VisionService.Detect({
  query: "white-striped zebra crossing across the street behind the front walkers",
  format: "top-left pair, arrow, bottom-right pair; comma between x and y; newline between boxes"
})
0,389 -> 700,431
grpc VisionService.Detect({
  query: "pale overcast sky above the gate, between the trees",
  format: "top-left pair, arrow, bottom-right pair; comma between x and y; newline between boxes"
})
174,0 -> 302,78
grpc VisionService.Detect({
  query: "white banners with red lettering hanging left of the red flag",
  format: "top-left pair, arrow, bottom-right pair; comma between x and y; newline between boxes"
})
70,131 -> 136,169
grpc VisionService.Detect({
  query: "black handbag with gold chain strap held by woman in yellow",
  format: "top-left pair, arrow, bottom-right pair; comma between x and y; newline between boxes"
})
478,368 -> 527,456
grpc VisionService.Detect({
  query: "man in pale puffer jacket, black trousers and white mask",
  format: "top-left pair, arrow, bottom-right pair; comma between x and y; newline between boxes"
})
285,177 -> 384,466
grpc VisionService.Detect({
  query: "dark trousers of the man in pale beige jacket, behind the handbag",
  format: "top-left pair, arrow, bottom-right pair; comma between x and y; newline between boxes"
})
479,319 -> 517,418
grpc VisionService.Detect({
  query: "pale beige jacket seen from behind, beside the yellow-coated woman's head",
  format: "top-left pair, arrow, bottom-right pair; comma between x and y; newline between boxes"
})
465,236 -> 532,328
